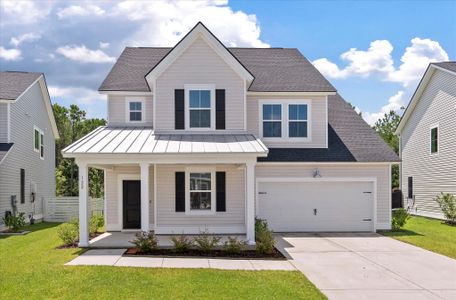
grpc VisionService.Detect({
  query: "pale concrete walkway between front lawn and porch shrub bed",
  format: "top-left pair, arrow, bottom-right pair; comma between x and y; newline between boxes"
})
65,249 -> 296,271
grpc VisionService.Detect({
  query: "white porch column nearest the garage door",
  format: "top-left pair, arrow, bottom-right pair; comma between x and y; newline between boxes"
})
245,162 -> 255,245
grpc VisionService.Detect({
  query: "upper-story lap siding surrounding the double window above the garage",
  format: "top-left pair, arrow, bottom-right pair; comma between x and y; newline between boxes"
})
247,96 -> 328,148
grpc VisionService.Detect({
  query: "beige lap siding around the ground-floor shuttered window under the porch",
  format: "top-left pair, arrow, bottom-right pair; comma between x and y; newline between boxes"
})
157,165 -> 245,229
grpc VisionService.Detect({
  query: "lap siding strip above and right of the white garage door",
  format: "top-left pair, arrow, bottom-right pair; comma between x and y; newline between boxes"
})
256,164 -> 391,224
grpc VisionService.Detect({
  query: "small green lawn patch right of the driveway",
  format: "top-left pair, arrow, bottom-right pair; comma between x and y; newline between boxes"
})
383,217 -> 456,259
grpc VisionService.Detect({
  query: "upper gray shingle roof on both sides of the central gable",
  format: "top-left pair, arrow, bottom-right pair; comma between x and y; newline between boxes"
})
99,47 -> 336,92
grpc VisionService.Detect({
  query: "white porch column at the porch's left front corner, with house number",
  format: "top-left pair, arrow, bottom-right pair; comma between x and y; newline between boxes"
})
76,161 -> 89,247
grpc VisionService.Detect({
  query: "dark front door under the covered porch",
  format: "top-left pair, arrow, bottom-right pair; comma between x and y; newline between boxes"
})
123,180 -> 141,229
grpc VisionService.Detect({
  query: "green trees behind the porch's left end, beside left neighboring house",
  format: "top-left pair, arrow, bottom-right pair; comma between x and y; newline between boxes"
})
53,104 -> 106,198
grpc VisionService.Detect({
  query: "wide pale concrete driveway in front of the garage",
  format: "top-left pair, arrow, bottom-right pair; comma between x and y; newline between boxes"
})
277,233 -> 456,300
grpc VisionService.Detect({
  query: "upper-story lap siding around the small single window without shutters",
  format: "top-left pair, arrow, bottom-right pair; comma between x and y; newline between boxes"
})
108,95 -> 153,126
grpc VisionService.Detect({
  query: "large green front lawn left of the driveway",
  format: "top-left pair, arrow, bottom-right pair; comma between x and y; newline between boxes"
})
0,223 -> 325,299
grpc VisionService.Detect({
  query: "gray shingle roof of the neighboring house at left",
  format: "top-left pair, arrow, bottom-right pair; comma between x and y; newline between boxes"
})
0,71 -> 43,100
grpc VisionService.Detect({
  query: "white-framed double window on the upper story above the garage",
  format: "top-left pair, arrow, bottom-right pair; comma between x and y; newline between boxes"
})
259,99 -> 310,141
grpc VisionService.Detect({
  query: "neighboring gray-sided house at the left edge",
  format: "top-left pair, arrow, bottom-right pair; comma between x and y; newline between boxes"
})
0,71 -> 59,227
